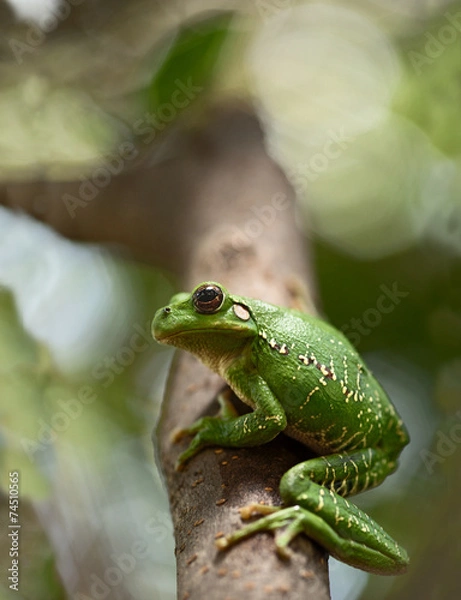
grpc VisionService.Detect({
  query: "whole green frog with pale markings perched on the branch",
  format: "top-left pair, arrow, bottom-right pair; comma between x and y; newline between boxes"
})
153,282 -> 409,575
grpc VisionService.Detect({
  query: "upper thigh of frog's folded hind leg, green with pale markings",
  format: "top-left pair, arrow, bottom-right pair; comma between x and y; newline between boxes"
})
280,448 -> 396,504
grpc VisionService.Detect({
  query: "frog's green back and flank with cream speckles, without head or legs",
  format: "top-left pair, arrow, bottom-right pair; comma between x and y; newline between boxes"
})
246,303 -> 408,455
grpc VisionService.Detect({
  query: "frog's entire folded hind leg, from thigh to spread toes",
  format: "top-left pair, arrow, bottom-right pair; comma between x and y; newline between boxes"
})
217,448 -> 408,575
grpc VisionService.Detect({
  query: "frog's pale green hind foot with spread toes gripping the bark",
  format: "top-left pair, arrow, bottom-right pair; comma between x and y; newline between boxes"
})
216,504 -> 304,559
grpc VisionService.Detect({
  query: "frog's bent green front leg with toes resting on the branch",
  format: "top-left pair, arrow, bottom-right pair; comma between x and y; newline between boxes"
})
174,373 -> 287,469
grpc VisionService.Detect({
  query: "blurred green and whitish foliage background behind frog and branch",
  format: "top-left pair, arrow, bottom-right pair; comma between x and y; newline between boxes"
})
0,0 -> 461,600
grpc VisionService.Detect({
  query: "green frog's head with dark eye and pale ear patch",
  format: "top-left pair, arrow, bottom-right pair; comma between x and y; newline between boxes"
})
152,282 -> 257,362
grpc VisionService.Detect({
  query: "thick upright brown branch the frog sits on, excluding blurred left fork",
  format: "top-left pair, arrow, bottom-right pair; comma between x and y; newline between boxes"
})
157,112 -> 329,600
